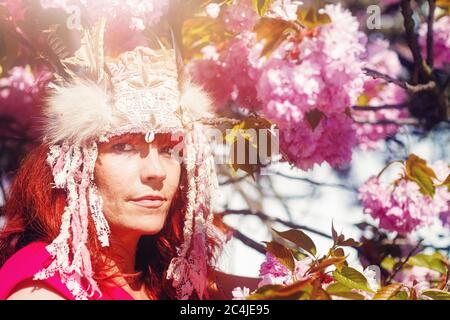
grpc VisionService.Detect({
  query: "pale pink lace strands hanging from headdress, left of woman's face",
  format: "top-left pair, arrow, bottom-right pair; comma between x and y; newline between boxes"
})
34,142 -> 109,300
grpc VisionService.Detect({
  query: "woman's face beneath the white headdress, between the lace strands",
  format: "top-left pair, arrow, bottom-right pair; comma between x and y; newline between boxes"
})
94,134 -> 181,237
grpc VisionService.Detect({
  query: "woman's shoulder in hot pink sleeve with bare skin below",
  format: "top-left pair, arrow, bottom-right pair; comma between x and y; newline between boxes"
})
0,241 -> 70,300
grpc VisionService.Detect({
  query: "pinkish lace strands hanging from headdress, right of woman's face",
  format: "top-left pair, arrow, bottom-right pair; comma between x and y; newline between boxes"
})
167,124 -> 225,300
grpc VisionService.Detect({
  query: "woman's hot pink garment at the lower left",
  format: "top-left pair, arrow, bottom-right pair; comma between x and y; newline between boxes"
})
0,242 -> 133,300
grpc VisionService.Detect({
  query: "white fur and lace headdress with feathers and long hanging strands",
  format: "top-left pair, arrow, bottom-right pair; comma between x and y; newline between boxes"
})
35,20 -> 223,299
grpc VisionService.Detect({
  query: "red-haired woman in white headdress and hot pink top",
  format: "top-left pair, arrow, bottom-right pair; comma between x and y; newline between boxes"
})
0,22 -> 256,299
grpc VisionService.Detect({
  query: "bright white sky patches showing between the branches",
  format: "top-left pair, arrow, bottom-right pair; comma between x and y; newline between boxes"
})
218,126 -> 450,277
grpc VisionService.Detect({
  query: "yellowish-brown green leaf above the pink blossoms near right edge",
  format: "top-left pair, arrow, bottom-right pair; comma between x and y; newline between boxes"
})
405,153 -> 437,196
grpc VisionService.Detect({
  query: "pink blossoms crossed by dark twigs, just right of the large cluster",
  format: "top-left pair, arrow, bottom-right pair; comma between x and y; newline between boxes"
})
353,39 -> 408,150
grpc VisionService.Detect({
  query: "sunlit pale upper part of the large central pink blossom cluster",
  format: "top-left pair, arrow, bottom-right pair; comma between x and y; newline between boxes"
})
258,5 -> 366,117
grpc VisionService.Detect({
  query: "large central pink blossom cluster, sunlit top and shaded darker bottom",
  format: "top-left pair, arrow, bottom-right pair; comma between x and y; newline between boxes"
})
253,4 -> 366,170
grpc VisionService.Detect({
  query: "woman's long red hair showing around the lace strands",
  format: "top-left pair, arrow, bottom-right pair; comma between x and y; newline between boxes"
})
0,144 -> 219,299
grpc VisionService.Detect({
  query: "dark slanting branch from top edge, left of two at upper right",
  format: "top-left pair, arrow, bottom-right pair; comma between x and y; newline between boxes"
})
400,0 -> 425,84
